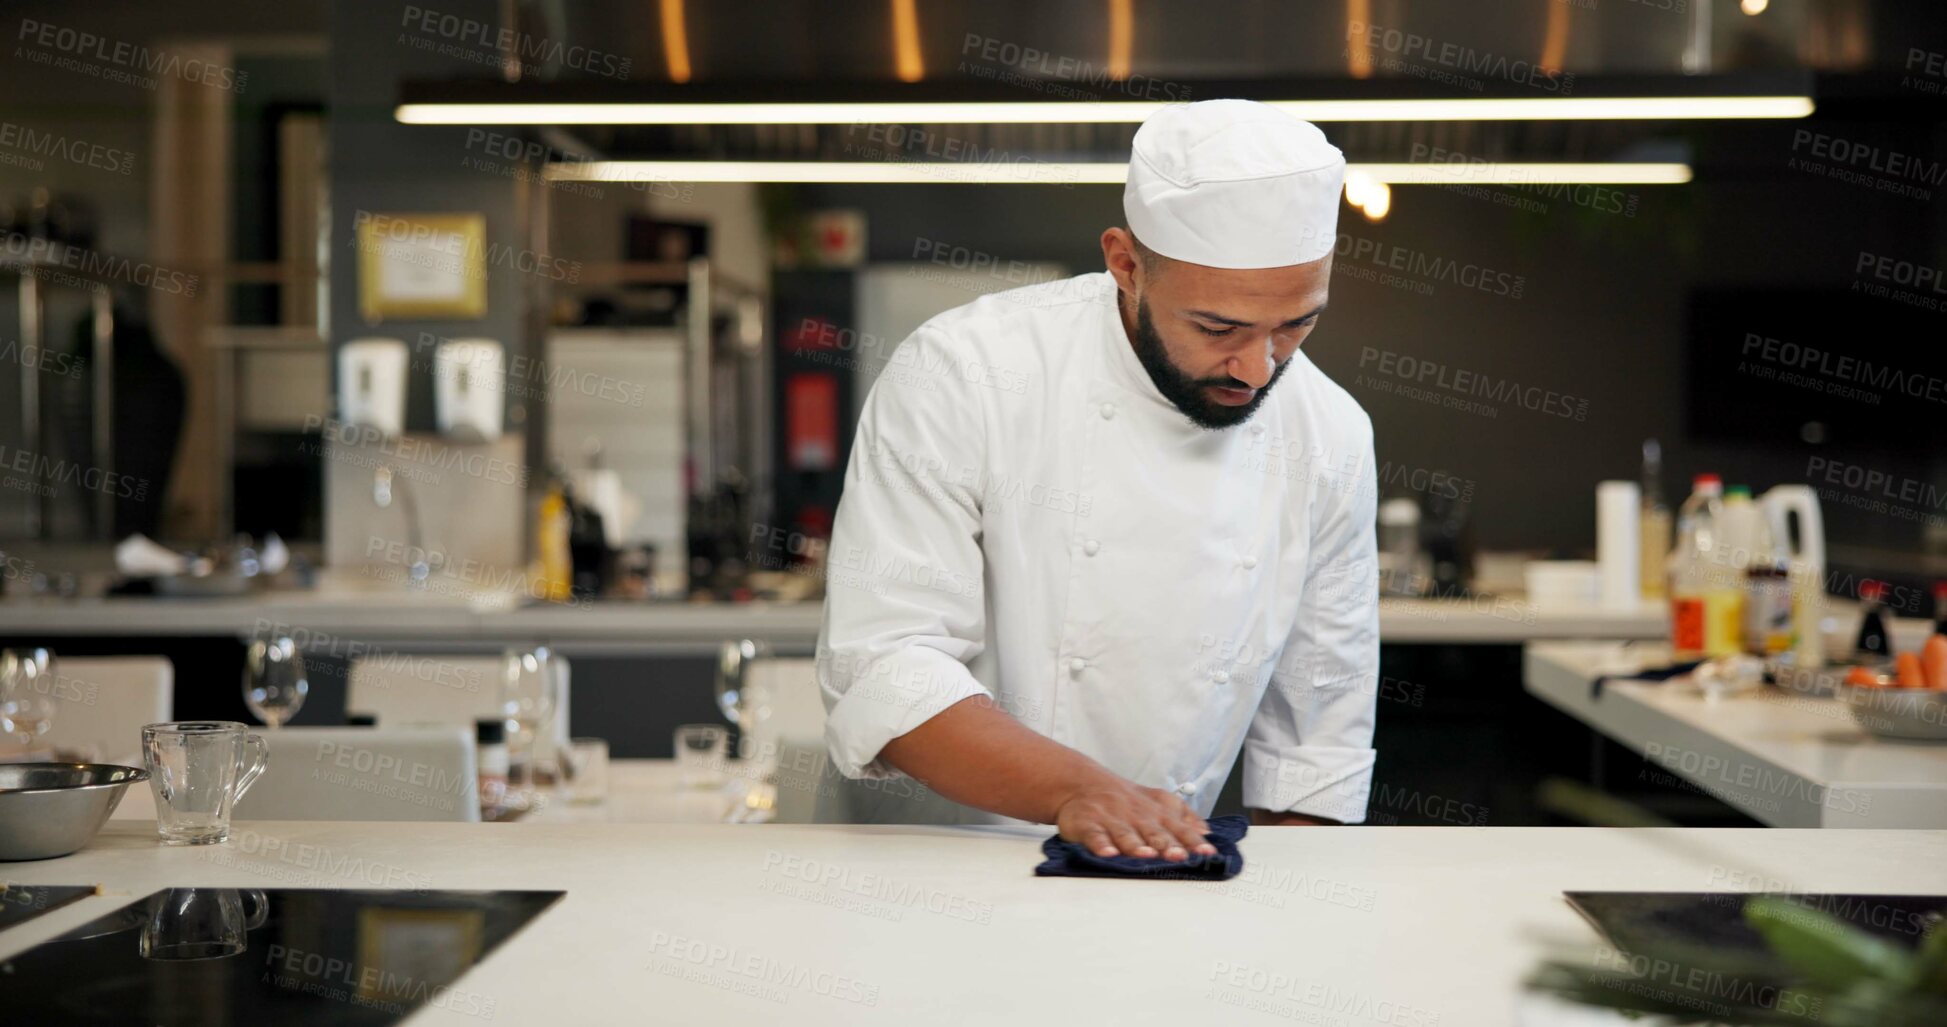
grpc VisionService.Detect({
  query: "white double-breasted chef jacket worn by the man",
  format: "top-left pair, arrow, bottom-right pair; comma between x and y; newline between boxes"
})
818,273 -> 1378,822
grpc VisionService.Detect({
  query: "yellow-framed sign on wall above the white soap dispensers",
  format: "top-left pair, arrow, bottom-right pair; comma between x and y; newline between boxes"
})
354,210 -> 487,323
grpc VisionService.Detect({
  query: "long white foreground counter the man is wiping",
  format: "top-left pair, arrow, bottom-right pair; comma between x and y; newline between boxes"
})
0,822 -> 1947,1027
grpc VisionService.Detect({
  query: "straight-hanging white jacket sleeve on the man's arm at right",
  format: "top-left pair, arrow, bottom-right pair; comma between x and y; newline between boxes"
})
1244,419 -> 1378,824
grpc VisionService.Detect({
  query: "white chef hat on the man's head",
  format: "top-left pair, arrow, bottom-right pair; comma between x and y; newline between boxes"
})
1121,99 -> 1345,267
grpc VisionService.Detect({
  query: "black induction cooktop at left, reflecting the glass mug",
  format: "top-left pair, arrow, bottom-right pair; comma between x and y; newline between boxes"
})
0,889 -> 563,1027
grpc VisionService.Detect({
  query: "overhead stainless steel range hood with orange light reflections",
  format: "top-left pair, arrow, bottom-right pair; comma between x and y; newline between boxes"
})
399,0 -> 1947,177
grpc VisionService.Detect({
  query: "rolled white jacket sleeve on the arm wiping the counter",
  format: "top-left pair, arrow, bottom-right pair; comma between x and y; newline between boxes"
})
818,327 -> 991,778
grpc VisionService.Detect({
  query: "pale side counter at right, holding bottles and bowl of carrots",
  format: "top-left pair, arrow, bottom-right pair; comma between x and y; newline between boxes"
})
1525,641 -> 1947,828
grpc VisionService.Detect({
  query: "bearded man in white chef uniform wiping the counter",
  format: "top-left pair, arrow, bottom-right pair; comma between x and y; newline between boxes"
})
818,99 -> 1378,859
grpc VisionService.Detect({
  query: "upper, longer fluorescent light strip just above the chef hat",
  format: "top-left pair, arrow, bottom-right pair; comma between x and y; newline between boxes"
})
393,95 -> 1813,125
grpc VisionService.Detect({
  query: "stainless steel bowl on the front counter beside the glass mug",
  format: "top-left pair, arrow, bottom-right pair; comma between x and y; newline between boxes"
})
0,764 -> 148,863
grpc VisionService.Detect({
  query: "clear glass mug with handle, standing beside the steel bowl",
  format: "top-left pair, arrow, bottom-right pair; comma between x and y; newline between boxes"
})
142,721 -> 271,846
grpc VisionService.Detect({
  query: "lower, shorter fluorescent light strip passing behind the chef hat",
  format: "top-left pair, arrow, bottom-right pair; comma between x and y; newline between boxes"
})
545,160 -> 1690,185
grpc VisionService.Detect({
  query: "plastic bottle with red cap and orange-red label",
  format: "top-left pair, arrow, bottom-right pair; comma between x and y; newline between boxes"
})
1671,474 -> 1743,659
